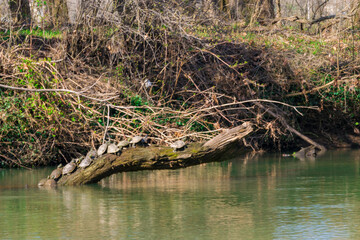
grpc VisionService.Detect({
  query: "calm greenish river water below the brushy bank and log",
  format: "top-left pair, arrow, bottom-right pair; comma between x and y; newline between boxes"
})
0,150 -> 360,239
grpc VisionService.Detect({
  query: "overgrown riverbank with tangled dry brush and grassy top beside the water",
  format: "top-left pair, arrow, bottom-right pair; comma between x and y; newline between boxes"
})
0,13 -> 360,167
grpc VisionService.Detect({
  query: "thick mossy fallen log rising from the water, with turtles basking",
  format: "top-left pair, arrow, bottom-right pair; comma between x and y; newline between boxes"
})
58,122 -> 253,186
